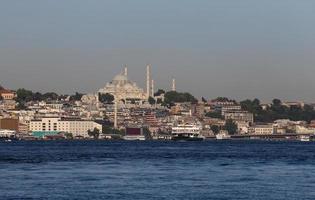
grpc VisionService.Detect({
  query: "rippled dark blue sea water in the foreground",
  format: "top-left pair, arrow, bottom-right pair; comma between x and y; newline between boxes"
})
0,141 -> 315,200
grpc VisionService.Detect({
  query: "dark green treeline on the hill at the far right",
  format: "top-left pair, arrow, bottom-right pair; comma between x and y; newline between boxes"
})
240,99 -> 315,122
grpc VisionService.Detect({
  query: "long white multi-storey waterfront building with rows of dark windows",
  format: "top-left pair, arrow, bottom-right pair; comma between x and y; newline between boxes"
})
29,118 -> 102,137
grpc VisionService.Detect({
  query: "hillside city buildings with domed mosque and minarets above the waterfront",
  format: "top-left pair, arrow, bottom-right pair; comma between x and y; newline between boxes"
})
0,65 -> 315,140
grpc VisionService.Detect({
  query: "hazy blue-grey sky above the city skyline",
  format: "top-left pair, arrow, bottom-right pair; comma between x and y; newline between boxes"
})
0,0 -> 315,102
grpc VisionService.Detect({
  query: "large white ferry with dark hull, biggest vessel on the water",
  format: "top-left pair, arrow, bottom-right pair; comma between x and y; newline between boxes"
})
171,124 -> 205,141
